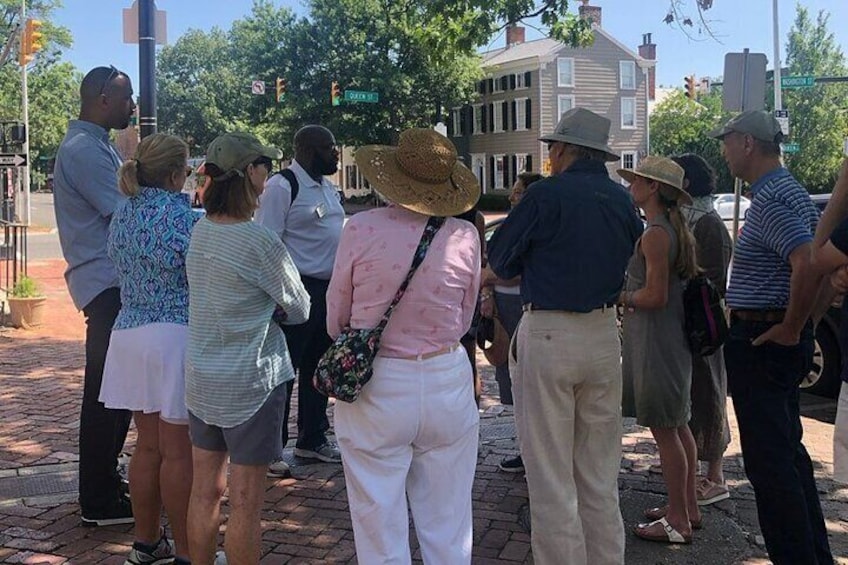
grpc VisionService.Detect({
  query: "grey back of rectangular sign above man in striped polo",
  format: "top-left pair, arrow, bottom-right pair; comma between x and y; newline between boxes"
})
721,49 -> 767,112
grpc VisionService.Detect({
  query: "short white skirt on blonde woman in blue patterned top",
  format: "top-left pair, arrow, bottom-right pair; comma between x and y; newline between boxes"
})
100,323 -> 188,424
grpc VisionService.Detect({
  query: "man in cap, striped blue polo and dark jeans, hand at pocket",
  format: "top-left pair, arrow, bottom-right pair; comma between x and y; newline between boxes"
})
710,111 -> 833,565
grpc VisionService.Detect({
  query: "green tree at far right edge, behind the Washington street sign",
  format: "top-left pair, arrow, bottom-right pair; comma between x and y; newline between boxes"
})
783,4 -> 848,193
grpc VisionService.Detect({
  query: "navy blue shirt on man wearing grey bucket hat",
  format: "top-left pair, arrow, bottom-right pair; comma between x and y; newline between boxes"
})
488,160 -> 643,312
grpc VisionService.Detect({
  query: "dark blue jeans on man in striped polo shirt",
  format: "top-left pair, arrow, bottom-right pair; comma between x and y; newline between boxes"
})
724,319 -> 833,565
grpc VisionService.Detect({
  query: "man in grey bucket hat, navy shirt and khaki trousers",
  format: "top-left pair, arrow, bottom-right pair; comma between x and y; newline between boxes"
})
489,108 -> 642,565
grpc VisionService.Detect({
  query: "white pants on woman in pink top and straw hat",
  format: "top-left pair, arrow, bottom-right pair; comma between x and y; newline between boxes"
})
335,347 -> 480,565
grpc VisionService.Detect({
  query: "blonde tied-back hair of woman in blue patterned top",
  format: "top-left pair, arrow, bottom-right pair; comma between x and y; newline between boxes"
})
118,133 -> 188,196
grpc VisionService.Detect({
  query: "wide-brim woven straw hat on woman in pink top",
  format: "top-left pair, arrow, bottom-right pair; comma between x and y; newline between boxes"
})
354,128 -> 480,216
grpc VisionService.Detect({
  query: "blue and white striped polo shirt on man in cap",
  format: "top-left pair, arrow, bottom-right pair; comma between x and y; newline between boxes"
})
727,167 -> 819,310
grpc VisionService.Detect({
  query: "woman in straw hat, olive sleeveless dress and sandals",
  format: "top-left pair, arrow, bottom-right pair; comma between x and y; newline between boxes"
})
618,157 -> 701,543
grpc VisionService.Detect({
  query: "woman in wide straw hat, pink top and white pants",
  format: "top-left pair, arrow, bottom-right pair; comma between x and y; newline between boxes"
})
327,129 -> 480,565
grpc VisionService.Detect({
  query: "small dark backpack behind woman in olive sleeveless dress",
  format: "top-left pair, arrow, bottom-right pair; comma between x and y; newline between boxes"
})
683,274 -> 728,357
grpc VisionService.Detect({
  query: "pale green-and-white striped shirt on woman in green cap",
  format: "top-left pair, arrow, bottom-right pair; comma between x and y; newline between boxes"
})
186,218 -> 309,428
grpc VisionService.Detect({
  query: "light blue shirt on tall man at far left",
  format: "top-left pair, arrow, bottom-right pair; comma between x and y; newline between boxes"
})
53,120 -> 124,310
